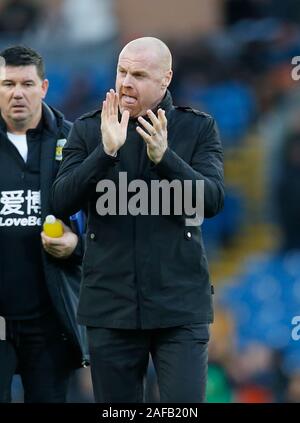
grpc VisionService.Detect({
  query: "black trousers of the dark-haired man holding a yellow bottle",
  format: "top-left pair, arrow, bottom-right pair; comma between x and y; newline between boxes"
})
0,313 -> 72,403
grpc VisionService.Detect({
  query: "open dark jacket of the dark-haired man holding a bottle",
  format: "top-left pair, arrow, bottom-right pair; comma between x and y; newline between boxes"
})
0,104 -> 88,367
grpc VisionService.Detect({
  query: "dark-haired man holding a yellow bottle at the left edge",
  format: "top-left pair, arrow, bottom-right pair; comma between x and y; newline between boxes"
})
0,46 -> 87,403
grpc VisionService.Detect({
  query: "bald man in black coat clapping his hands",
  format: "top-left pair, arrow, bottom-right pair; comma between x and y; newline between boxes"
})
53,37 -> 224,403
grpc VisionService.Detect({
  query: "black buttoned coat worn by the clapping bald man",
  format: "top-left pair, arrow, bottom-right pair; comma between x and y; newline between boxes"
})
53,93 -> 224,329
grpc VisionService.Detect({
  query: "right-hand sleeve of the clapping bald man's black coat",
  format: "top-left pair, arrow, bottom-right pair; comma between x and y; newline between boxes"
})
154,115 -> 224,217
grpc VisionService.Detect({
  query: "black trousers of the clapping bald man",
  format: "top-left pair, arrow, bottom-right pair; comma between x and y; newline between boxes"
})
88,324 -> 209,403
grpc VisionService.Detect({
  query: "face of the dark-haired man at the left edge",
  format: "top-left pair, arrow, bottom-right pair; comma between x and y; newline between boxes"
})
0,65 -> 48,127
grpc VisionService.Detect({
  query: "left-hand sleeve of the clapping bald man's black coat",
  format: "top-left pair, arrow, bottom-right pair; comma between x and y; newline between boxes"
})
52,119 -> 118,216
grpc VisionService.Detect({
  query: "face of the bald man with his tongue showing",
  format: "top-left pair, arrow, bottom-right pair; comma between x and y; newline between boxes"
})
116,49 -> 168,117
